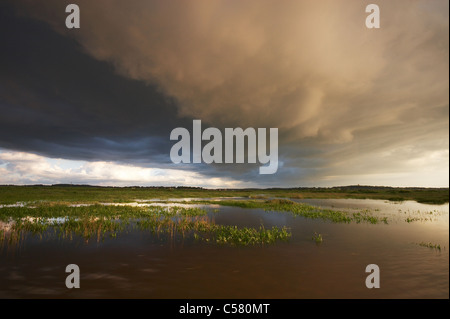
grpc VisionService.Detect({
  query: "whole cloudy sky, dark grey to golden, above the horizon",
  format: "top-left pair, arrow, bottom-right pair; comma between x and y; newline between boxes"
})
0,0 -> 449,188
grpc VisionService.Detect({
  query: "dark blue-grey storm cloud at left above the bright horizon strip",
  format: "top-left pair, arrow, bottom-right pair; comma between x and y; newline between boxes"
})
0,4 -> 192,163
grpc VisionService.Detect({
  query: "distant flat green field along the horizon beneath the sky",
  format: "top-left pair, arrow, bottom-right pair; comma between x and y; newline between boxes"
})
0,185 -> 449,204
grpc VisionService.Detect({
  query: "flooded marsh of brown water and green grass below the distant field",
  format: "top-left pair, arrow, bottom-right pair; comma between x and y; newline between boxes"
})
0,192 -> 449,298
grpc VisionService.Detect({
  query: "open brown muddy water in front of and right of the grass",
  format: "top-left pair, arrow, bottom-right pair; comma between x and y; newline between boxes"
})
0,200 -> 449,298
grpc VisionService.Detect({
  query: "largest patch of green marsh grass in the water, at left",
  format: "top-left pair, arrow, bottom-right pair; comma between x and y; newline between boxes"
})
0,204 -> 291,245
